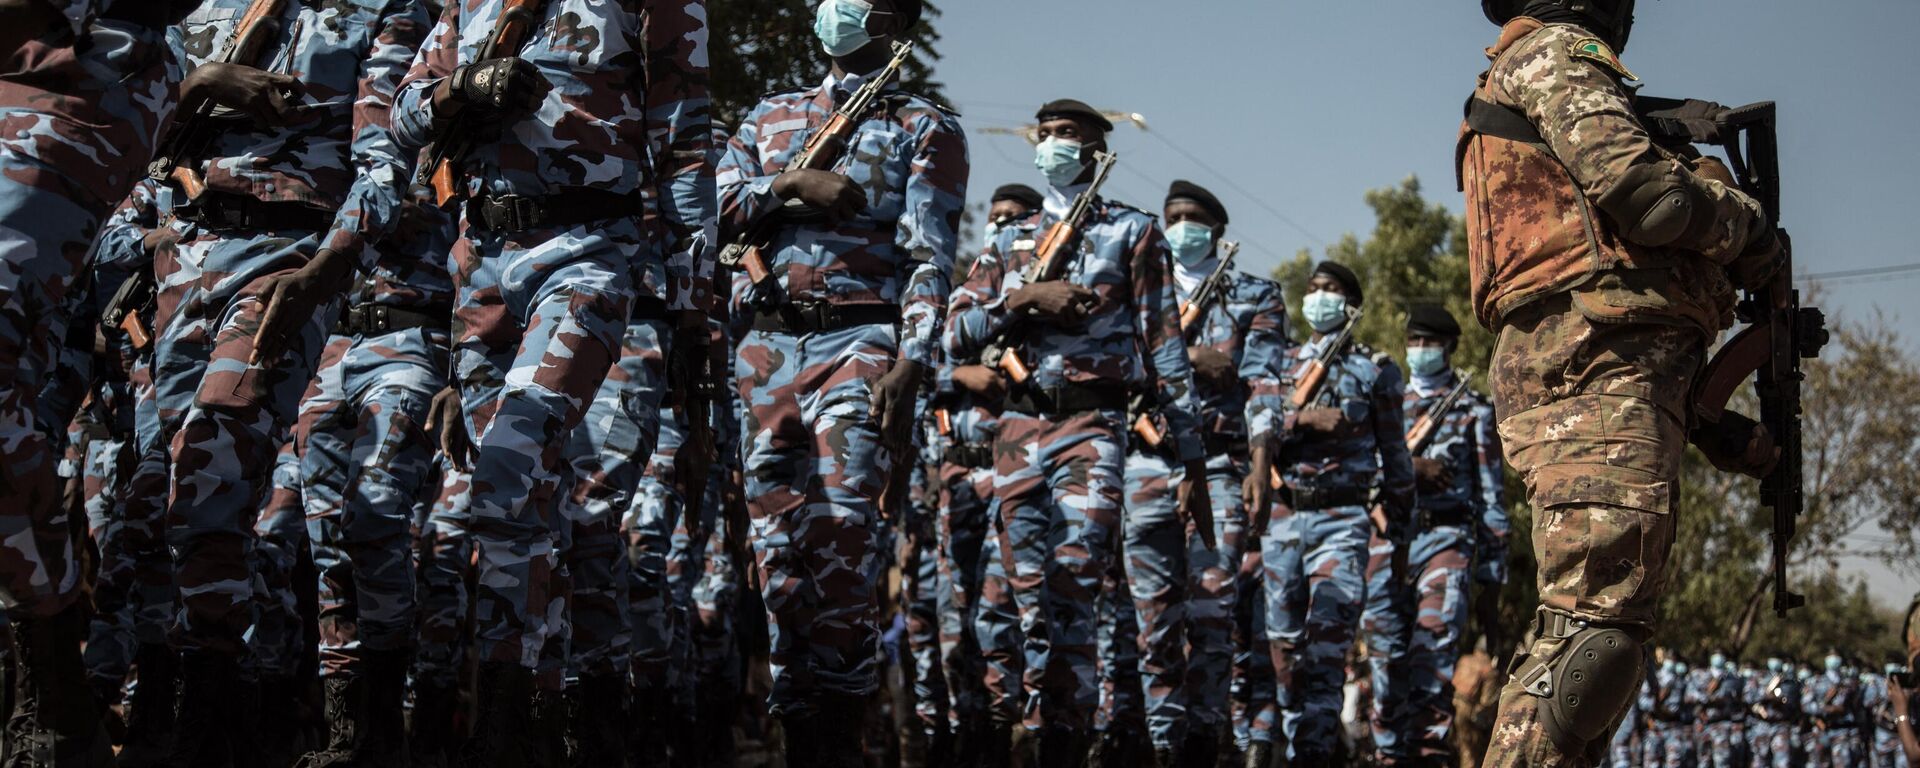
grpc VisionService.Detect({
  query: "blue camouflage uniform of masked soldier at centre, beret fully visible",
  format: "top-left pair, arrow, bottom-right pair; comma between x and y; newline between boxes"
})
947,188 -> 1202,745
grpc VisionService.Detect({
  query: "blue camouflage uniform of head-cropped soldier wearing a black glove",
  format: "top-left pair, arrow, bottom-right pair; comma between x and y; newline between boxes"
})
394,0 -> 710,672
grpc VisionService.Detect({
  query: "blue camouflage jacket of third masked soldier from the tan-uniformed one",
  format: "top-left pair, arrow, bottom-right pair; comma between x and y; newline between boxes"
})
1173,259 -> 1292,442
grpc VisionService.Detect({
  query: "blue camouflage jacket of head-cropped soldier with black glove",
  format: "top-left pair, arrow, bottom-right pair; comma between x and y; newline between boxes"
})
394,0 -> 712,311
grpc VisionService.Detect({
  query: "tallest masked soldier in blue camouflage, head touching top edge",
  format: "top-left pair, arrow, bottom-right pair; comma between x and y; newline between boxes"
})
720,0 -> 968,766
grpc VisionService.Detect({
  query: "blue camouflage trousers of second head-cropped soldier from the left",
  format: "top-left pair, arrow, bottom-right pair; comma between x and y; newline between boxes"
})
154,227 -> 334,657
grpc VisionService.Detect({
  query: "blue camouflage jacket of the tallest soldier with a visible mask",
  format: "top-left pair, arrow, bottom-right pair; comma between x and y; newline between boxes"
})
720,75 -> 970,365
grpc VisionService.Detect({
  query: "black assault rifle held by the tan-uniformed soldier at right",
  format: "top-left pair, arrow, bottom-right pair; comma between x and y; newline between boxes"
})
1666,98 -> 1828,616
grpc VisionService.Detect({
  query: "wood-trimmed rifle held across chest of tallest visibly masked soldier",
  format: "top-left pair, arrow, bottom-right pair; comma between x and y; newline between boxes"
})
720,42 -> 914,300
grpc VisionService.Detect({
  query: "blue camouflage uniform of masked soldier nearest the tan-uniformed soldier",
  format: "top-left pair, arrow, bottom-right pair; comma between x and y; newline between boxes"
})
1361,372 -> 1511,758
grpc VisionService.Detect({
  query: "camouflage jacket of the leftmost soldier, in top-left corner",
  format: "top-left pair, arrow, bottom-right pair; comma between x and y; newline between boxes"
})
0,0 -> 180,213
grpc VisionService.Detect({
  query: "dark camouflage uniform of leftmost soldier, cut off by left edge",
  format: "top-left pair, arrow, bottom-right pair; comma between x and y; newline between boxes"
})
0,0 -> 179,616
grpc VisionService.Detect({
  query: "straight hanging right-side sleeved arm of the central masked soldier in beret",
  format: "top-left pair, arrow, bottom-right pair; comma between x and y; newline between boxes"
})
1129,225 -> 1206,463
